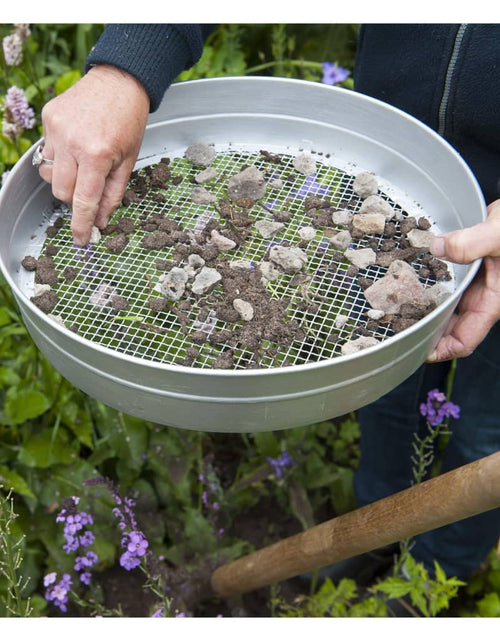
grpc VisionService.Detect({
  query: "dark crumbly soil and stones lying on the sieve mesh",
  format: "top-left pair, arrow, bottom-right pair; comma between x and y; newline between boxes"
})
22,143 -> 451,369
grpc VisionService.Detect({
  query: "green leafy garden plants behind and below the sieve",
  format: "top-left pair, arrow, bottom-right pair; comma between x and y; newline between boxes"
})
0,24 -> 500,617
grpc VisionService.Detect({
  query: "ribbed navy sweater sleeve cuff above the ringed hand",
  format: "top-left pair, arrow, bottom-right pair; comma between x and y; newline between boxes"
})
85,24 -> 214,111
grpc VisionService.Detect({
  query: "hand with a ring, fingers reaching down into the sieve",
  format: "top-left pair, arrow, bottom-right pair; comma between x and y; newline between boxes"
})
39,65 -> 149,245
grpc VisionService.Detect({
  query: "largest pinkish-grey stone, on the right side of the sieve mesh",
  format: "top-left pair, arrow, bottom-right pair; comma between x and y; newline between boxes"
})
364,260 -> 429,314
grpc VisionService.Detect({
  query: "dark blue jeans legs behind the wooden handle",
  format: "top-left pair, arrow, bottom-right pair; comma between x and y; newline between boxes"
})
354,324 -> 500,579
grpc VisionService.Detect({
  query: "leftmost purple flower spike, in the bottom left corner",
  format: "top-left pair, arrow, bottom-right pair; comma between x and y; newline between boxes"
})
44,496 -> 99,612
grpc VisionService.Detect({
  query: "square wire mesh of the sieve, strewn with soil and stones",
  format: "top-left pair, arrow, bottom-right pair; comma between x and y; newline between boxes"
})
24,148 -> 454,369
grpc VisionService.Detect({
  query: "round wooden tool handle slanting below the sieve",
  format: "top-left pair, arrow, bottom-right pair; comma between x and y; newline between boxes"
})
211,452 -> 500,597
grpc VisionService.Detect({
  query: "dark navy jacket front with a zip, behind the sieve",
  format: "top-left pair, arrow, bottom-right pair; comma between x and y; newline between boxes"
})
354,24 -> 500,203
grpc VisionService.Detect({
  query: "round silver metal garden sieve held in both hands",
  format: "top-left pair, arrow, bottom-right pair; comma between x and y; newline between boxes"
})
0,77 -> 486,432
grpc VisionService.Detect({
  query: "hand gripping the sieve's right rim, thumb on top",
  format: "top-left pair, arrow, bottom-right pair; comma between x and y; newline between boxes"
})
427,200 -> 500,363
